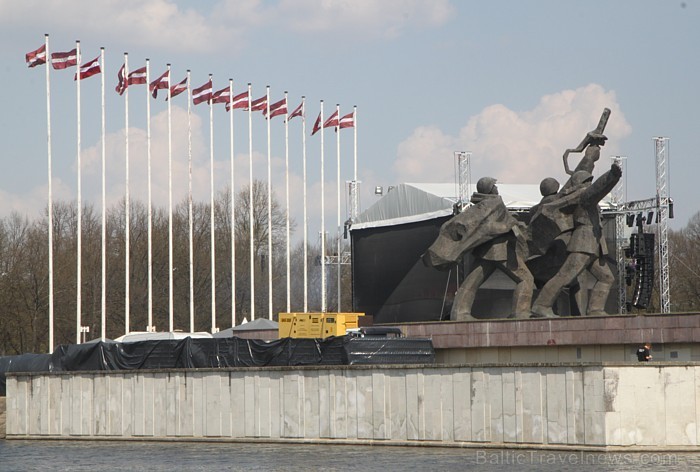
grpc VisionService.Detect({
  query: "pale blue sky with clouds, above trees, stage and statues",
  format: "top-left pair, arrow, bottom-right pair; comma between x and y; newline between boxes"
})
0,0 -> 700,234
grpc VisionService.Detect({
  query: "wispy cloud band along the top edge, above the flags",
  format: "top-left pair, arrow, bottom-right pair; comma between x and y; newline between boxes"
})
0,0 -> 452,53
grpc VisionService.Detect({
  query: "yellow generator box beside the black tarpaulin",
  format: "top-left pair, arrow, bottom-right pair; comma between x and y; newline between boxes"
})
278,313 -> 364,339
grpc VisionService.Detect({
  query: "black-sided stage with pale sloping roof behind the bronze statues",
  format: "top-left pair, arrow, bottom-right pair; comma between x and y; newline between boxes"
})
350,182 -> 617,323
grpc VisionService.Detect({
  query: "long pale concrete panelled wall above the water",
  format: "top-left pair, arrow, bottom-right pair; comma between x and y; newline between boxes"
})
7,364 -> 700,448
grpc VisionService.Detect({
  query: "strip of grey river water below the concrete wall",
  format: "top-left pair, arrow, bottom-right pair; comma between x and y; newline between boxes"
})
0,440 -> 700,472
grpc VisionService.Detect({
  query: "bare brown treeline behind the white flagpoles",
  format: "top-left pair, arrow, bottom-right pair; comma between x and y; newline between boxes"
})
0,181 -> 351,355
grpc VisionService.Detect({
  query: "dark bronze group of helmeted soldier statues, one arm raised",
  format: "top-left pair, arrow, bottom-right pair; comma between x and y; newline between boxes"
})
423,108 -> 622,321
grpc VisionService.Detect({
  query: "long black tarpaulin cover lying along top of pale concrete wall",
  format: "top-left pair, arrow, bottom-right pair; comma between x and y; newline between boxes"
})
0,336 -> 435,396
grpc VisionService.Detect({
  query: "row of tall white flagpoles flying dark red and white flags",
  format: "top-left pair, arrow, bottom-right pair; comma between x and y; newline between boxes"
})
26,34 -> 358,352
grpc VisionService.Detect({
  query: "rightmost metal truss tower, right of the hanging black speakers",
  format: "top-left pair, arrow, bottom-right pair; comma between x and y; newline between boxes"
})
654,136 -> 671,313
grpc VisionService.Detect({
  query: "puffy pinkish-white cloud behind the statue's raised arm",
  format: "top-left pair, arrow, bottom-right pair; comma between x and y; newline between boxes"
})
394,84 -> 631,183
